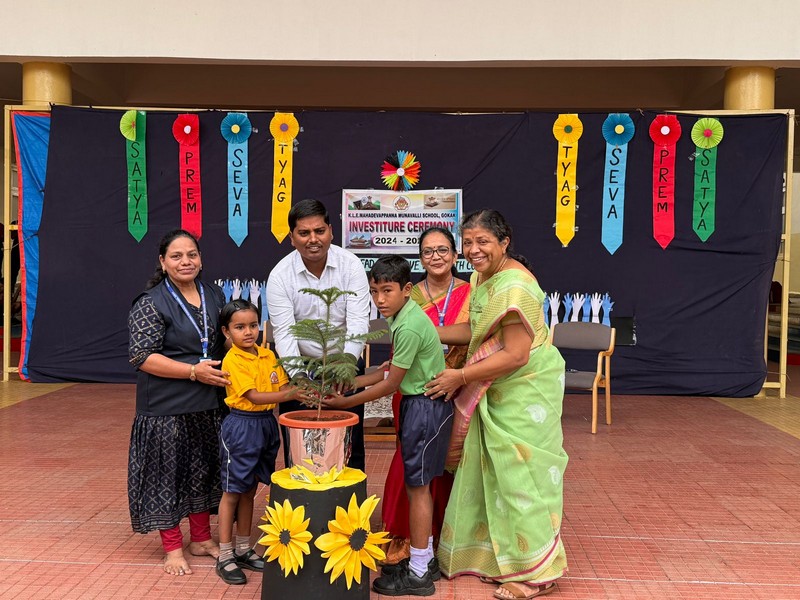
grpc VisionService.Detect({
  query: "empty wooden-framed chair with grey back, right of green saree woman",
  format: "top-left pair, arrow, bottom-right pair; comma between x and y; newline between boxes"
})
550,321 -> 617,433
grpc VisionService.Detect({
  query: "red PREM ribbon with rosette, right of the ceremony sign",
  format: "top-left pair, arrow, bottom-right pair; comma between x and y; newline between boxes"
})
650,115 -> 681,249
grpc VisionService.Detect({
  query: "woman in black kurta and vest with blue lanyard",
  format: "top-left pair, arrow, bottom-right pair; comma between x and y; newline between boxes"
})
128,230 -> 228,575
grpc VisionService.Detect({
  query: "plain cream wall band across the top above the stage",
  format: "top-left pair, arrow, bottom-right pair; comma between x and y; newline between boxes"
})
0,0 -> 800,66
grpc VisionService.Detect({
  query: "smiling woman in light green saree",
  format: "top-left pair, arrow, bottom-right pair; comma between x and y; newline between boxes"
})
428,209 -> 567,600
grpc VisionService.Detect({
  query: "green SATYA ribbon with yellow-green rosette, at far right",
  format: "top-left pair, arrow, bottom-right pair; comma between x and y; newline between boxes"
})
692,117 -> 725,242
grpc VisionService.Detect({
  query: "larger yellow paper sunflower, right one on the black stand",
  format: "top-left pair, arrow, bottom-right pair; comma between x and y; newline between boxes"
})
314,494 -> 389,590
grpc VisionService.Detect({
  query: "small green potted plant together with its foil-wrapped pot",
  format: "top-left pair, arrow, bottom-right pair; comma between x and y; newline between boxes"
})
278,287 -> 385,475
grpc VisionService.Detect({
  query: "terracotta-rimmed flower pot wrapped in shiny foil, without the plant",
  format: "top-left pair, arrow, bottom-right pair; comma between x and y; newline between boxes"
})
278,410 -> 358,475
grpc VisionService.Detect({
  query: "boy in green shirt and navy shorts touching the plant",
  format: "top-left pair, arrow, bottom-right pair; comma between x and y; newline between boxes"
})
326,255 -> 453,596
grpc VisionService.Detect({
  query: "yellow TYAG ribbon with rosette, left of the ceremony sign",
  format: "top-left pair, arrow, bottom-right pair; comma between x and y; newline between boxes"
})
269,112 -> 300,242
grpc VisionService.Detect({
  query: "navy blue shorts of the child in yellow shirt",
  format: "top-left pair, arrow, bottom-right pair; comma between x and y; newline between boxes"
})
219,409 -> 281,494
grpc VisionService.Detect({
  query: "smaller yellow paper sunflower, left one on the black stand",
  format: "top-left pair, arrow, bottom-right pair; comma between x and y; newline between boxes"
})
258,500 -> 311,577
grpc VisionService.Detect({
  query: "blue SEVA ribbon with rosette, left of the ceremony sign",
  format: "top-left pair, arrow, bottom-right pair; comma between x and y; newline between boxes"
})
219,113 -> 253,246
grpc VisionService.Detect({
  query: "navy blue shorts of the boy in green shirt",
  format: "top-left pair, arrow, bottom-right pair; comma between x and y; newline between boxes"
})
400,396 -> 453,487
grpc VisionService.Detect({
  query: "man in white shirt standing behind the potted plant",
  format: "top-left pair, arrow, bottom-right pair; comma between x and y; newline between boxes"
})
267,199 -> 370,470
